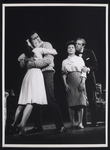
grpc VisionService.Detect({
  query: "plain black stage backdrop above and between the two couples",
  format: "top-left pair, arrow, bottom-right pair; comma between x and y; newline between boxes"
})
5,6 -> 106,122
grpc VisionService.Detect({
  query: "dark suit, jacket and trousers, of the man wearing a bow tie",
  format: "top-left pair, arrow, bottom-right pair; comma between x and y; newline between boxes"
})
76,49 -> 98,126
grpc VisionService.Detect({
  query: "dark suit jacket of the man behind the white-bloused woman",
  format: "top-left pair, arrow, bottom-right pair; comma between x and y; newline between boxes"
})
76,49 -> 98,89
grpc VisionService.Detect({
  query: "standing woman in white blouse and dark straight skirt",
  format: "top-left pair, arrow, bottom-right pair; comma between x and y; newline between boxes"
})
62,41 -> 86,128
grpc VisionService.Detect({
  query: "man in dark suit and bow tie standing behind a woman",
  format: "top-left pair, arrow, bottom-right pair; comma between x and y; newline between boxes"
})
76,38 -> 98,127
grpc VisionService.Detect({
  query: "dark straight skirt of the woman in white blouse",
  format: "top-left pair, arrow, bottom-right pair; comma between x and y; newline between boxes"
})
67,71 -> 86,107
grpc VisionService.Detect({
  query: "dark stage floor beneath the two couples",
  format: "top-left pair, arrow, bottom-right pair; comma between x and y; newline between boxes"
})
5,122 -> 106,146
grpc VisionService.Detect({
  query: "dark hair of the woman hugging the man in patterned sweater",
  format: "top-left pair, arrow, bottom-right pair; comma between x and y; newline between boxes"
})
23,44 -> 34,58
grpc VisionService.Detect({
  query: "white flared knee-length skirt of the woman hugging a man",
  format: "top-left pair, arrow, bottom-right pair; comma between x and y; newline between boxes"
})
18,68 -> 47,105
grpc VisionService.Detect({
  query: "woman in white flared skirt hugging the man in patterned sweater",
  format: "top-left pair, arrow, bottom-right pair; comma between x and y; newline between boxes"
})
11,45 -> 57,135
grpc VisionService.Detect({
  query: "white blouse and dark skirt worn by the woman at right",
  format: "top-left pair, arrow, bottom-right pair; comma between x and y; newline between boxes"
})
62,55 -> 86,107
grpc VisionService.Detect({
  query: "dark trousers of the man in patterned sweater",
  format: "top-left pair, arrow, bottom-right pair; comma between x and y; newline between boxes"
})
34,71 -> 64,130
